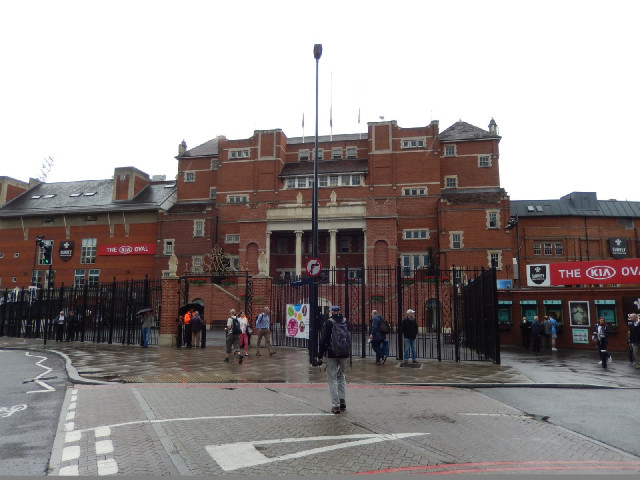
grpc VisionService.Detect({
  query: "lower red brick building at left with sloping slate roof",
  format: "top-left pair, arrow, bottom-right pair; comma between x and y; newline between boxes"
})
0,167 -> 176,289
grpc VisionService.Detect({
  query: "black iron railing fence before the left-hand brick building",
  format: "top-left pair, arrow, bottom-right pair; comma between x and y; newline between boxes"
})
0,280 -> 162,345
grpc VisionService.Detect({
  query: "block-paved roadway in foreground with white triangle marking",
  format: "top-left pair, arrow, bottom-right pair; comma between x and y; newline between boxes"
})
51,384 -> 640,477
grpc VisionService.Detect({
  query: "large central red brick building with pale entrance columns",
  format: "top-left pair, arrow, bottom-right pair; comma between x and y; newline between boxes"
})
165,120 -> 511,280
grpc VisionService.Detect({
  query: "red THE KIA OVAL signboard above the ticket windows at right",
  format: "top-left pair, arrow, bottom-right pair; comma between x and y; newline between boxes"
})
549,259 -> 640,285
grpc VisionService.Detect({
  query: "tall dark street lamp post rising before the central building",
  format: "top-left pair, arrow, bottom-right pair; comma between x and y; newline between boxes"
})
309,43 -> 322,366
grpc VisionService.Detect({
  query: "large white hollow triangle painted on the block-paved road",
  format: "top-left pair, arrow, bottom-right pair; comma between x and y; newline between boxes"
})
205,433 -> 429,471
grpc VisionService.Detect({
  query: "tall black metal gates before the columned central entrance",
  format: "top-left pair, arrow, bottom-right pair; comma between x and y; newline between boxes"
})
271,266 -> 500,363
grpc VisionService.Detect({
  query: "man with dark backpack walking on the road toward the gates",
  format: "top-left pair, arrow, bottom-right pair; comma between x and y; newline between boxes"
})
317,305 -> 351,414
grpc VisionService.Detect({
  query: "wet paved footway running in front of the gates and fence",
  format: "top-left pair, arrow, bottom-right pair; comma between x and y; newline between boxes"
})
0,337 -> 640,388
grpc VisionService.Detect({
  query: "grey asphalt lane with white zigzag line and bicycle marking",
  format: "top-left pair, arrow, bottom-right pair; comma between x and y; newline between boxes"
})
0,350 -> 67,476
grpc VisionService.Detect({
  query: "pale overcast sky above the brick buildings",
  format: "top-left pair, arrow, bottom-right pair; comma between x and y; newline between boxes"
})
0,0 -> 640,201
